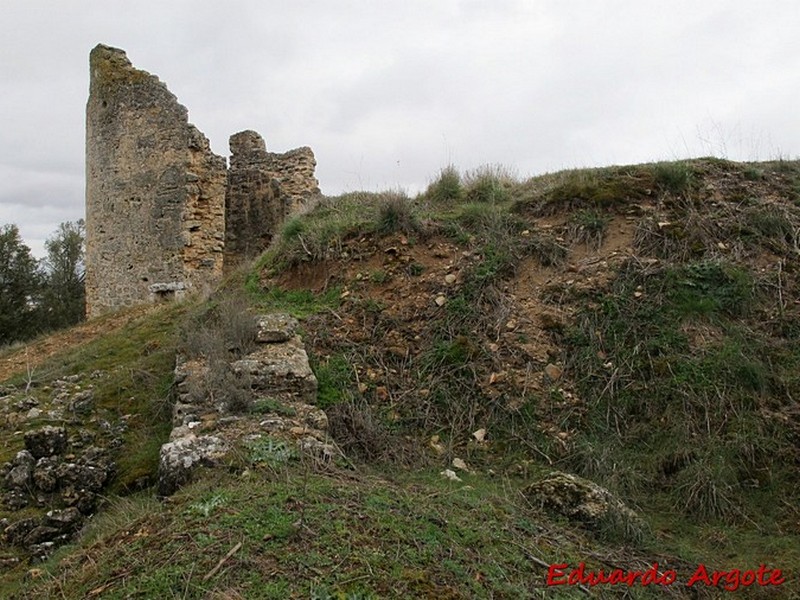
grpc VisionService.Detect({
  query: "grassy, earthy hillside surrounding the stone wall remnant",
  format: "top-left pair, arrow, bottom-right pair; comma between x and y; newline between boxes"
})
0,158 -> 800,598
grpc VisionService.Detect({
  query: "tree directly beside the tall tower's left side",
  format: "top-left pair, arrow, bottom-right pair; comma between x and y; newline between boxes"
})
40,219 -> 86,329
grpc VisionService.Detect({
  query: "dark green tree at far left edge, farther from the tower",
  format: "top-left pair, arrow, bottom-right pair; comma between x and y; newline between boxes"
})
0,225 -> 42,345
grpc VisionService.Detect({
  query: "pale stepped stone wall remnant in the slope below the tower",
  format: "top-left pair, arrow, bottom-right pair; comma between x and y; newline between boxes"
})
158,314 -> 339,496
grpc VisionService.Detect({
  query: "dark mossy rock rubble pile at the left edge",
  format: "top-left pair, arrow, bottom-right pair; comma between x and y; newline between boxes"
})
0,375 -> 119,566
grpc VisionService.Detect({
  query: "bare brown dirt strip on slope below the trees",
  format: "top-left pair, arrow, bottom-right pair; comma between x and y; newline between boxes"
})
0,306 -> 151,382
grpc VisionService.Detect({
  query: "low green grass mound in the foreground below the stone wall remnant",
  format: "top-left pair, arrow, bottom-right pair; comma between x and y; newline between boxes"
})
3,468 -> 680,599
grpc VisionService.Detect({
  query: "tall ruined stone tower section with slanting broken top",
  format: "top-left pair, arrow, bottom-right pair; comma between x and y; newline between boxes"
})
86,45 -> 227,317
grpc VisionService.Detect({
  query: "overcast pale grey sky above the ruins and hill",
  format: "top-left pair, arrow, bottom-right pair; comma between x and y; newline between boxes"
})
0,0 -> 800,255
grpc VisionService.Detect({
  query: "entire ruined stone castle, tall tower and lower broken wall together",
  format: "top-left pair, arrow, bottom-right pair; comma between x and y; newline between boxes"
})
86,45 -> 319,318
